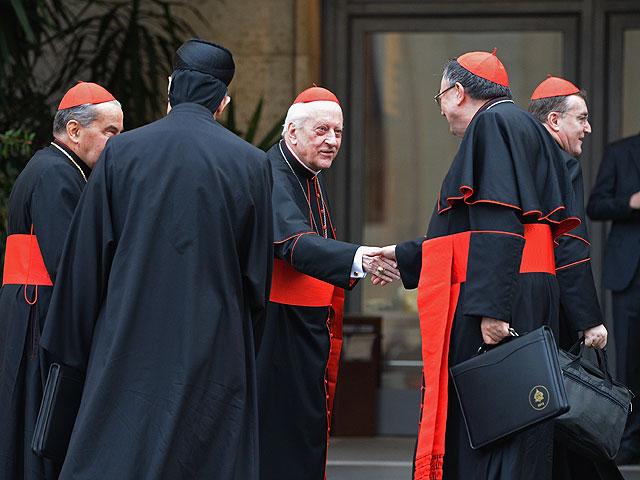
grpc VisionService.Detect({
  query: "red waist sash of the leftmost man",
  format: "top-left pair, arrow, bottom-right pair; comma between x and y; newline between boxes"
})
2,234 -> 53,286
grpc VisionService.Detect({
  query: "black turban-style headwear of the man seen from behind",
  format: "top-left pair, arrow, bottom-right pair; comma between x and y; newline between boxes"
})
169,38 -> 235,113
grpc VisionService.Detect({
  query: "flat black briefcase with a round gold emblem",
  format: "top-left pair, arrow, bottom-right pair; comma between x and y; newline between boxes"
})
450,326 -> 569,449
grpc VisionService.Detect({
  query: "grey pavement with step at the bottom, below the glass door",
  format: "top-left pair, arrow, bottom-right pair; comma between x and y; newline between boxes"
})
327,437 -> 640,480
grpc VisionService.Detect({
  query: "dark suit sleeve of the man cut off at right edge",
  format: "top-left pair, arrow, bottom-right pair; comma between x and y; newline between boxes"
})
587,147 -> 640,220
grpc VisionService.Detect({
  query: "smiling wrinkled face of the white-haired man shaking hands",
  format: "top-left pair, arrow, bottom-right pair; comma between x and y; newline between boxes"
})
288,102 -> 342,172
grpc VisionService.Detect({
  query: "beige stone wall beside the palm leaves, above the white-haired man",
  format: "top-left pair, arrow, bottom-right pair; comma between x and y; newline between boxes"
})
183,0 -> 321,139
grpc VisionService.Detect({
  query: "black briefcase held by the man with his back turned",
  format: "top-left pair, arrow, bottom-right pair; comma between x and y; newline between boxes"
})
31,363 -> 84,463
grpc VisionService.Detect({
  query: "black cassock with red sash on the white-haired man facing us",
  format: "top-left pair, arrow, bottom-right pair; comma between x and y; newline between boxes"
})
258,141 -> 358,480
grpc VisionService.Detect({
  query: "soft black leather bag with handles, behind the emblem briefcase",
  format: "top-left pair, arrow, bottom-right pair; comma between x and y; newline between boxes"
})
555,339 -> 633,460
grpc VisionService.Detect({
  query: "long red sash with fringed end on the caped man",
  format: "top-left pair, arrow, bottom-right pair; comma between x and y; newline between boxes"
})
414,224 -> 555,480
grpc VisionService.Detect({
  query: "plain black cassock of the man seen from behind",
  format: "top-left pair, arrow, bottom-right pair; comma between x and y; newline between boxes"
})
37,103 -> 273,480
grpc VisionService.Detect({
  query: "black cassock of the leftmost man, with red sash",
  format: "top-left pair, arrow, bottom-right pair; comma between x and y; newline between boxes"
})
0,141 -> 91,480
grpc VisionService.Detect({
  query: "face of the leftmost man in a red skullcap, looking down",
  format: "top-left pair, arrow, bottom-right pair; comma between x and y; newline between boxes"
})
77,103 -> 123,168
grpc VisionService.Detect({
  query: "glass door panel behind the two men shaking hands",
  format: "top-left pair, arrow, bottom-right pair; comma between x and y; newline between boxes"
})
360,31 -> 563,434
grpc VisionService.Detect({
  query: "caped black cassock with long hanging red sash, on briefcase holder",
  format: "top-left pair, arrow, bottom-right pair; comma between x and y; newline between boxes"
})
396,99 -> 579,480
